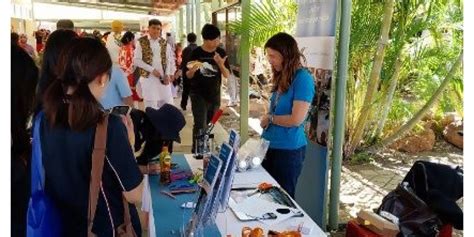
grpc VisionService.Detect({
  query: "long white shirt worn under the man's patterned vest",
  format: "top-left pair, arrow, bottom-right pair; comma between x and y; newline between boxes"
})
133,36 -> 176,104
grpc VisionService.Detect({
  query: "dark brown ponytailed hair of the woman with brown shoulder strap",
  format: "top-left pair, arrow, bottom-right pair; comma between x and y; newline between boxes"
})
44,38 -> 112,131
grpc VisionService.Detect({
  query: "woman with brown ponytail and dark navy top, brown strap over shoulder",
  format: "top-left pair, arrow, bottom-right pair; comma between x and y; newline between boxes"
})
40,38 -> 143,236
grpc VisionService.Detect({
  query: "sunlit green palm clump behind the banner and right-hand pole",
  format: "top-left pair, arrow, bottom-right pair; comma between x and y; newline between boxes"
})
344,0 -> 463,158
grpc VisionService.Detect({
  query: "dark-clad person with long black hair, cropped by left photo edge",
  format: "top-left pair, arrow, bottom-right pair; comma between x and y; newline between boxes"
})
10,44 -> 38,236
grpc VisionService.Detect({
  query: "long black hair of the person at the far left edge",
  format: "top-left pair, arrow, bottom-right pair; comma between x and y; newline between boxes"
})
11,44 -> 38,161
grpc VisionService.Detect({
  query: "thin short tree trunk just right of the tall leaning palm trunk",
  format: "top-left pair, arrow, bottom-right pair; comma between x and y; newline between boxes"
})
374,50 -> 402,139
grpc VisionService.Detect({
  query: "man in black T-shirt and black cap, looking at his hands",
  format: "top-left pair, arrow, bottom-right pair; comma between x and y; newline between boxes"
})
186,24 -> 230,153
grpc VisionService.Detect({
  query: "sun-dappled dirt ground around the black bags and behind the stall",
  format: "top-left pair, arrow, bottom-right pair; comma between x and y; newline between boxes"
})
220,96 -> 463,236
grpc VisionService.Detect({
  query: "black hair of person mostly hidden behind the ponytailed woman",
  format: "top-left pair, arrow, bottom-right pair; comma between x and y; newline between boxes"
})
38,30 -> 77,110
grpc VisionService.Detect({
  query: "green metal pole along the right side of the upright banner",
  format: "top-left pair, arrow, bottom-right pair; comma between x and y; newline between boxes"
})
329,0 -> 352,230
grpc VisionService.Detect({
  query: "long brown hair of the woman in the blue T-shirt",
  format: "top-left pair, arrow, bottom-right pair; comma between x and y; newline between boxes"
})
264,32 -> 305,92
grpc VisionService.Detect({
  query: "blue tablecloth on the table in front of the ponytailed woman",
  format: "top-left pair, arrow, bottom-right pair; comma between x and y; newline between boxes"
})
149,154 -> 221,237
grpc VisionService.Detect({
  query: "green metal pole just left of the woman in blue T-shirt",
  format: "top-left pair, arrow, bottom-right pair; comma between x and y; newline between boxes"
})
240,0 -> 251,144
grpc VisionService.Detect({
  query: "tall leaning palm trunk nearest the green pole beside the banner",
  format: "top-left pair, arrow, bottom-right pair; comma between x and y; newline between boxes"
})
345,0 -> 395,157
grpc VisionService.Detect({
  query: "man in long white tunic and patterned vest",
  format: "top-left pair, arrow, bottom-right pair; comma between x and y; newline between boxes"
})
134,19 -> 176,109
